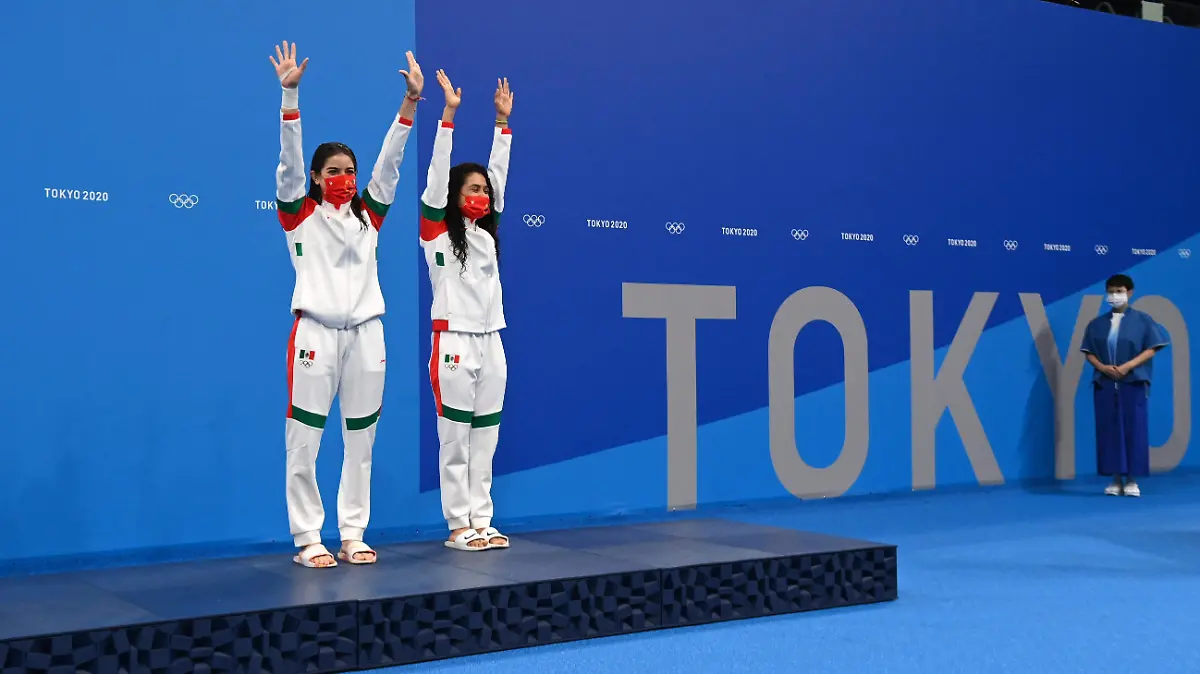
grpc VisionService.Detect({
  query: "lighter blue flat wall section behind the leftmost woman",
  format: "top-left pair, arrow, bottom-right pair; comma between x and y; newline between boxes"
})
0,0 -> 419,560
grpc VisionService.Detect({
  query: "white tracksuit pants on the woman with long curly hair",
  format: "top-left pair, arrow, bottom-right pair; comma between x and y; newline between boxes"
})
430,332 -> 509,531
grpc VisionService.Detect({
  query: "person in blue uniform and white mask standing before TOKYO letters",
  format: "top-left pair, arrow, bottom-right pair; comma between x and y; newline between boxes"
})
1080,273 -> 1168,497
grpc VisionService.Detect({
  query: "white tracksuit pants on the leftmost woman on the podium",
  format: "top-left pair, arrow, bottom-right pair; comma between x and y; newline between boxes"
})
287,317 -> 386,547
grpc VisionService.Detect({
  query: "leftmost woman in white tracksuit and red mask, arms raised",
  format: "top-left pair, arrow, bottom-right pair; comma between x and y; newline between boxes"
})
271,42 -> 425,568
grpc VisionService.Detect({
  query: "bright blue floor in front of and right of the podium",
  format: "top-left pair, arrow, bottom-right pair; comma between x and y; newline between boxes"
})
385,475 -> 1200,674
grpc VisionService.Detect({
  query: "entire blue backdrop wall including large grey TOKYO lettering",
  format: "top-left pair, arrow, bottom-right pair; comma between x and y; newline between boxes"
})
0,0 -> 1200,567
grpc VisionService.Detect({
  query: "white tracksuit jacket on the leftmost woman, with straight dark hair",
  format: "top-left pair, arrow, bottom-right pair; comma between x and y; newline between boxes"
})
276,113 -> 413,329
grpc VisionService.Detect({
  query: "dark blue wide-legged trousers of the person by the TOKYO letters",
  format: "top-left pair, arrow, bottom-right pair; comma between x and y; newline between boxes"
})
1093,379 -> 1150,477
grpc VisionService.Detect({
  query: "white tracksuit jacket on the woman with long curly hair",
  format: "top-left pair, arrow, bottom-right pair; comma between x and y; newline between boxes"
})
421,122 -> 512,333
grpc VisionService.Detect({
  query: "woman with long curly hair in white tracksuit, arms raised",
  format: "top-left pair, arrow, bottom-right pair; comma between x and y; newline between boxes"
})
420,71 -> 512,552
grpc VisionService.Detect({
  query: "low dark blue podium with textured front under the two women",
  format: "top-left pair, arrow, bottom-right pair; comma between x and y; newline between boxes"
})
0,519 -> 898,674
